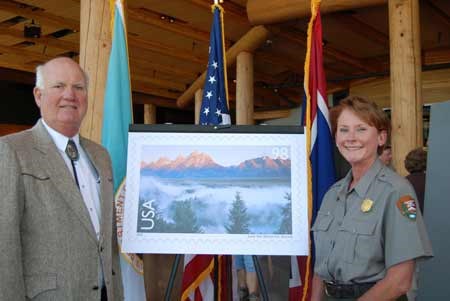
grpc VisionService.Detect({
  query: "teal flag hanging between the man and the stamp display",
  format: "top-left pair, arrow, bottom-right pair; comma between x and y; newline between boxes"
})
102,0 -> 145,301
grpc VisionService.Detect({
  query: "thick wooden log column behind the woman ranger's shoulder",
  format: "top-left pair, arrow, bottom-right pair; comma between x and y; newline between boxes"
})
389,0 -> 423,175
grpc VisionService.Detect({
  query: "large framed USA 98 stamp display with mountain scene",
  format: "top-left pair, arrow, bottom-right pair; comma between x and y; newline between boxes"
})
122,125 -> 308,255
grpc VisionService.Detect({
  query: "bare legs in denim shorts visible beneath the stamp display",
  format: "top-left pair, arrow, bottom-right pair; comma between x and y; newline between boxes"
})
234,255 -> 259,301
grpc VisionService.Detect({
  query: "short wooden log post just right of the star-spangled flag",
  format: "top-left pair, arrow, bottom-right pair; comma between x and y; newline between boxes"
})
236,51 -> 254,125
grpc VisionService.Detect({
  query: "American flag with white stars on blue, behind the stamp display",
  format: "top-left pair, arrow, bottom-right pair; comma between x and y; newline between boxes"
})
181,4 -> 231,301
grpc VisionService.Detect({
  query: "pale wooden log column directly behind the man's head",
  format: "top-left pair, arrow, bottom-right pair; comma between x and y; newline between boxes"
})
80,0 -> 111,142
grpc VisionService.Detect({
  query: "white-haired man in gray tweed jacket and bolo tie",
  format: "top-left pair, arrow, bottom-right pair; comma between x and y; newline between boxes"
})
0,58 -> 123,301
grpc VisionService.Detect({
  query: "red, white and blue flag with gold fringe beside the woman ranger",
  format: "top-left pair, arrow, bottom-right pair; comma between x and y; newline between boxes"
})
289,0 -> 335,301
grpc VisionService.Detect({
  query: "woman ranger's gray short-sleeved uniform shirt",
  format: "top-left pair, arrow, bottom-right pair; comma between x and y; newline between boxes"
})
312,159 -> 433,283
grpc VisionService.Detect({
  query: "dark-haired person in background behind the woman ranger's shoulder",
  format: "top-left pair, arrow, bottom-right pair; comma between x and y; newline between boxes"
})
405,147 -> 427,214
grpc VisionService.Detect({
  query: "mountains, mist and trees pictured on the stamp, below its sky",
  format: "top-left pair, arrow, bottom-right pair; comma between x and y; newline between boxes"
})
138,151 -> 292,235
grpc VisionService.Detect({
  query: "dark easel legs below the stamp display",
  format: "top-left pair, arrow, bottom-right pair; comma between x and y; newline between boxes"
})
164,254 -> 269,301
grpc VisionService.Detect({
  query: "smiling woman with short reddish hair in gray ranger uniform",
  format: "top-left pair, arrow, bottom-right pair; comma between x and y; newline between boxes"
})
311,96 -> 432,301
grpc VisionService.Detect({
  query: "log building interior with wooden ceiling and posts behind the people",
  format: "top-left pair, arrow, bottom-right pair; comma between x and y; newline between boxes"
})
0,0 -> 450,300
